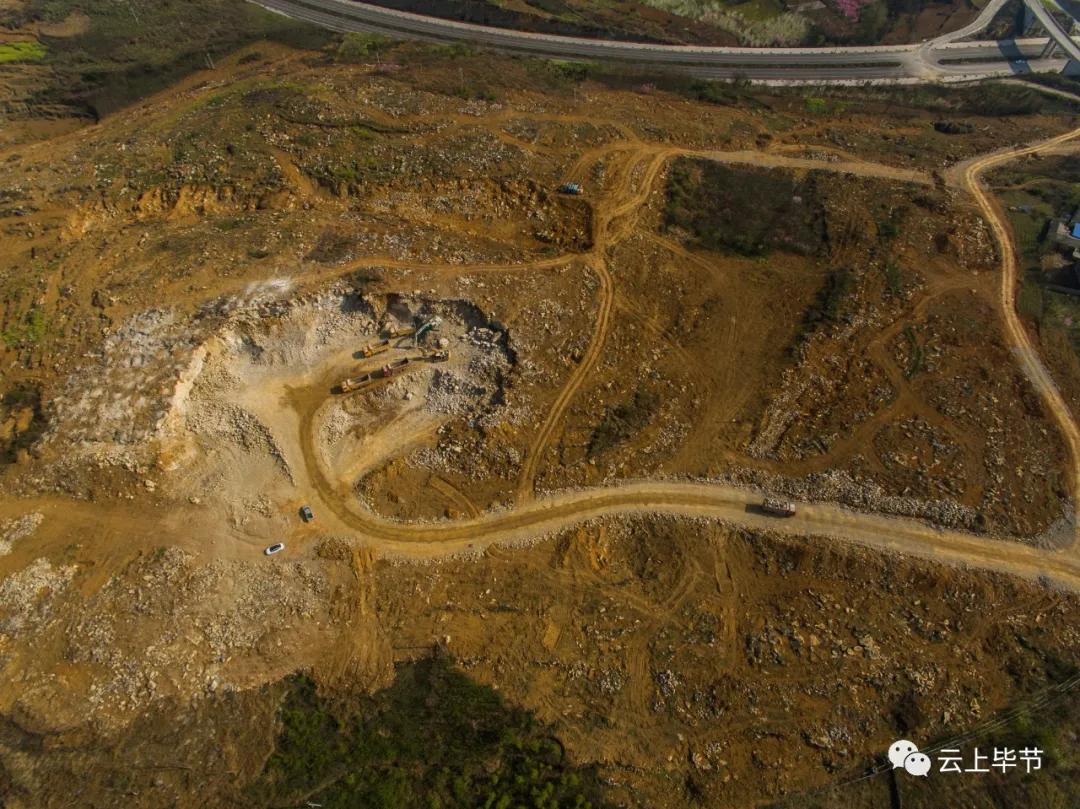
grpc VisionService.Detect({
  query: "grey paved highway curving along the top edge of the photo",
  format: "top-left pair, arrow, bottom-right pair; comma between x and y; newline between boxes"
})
249,0 -> 1076,82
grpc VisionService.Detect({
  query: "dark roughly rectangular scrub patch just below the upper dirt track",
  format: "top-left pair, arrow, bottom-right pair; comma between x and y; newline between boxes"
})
664,159 -> 827,256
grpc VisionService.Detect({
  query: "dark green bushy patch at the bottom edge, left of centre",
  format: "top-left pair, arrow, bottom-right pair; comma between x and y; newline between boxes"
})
249,655 -> 603,809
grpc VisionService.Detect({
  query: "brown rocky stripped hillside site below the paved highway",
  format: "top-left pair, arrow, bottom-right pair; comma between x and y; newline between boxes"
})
0,28 -> 1080,807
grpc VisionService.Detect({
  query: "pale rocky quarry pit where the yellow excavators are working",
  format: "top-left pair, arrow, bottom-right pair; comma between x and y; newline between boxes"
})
162,282 -> 513,524
